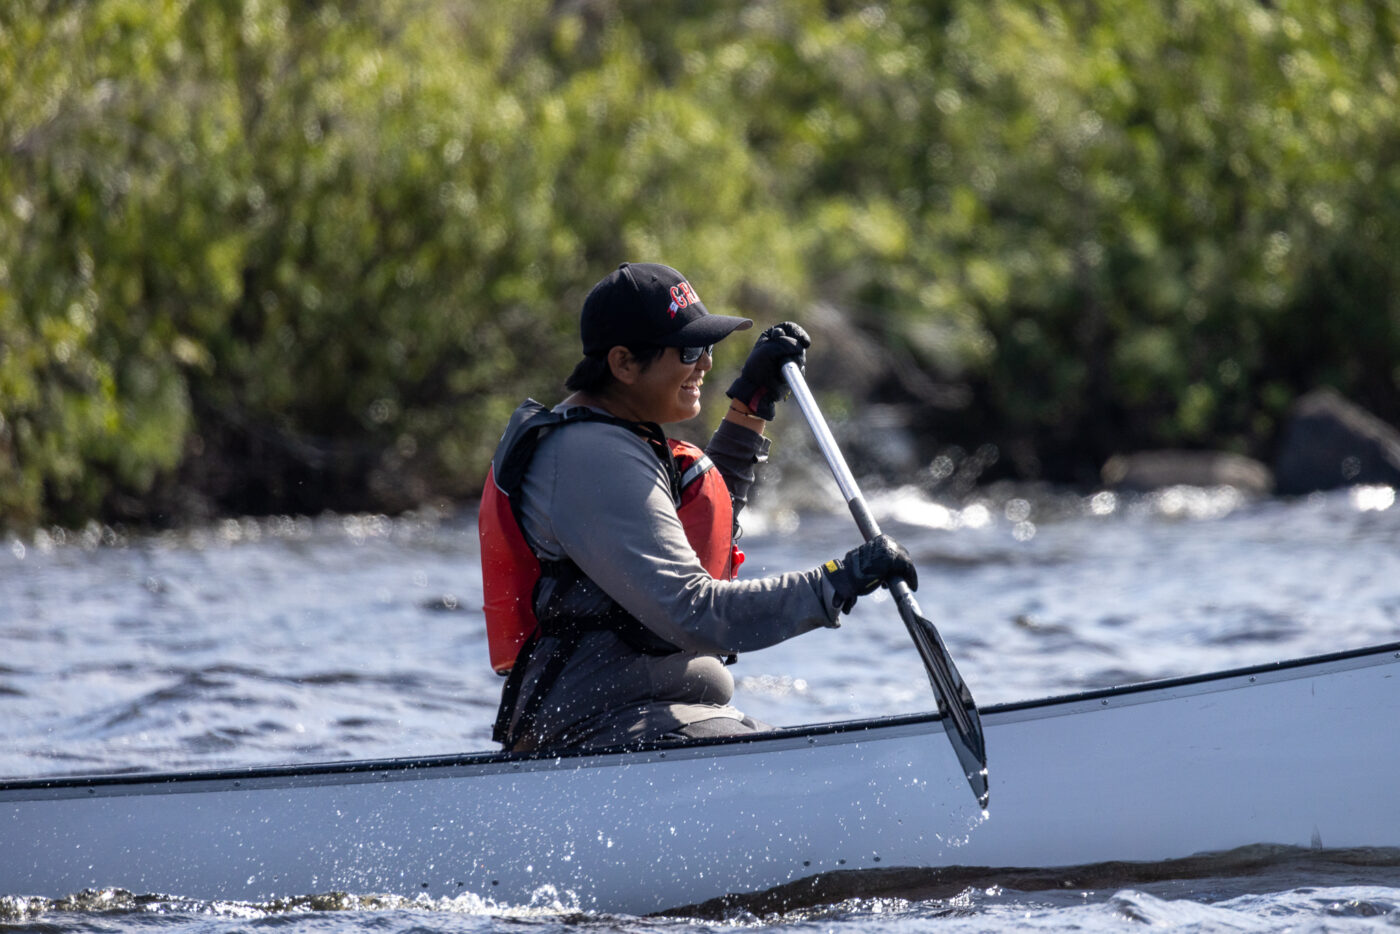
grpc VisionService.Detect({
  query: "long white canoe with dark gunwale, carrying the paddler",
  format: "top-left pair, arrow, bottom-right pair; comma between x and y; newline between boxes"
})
0,643 -> 1400,913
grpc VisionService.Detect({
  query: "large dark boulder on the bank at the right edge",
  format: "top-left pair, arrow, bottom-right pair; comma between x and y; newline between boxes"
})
1274,389 -> 1400,496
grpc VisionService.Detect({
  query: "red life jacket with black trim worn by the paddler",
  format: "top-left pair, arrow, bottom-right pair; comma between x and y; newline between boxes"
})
477,399 -> 743,675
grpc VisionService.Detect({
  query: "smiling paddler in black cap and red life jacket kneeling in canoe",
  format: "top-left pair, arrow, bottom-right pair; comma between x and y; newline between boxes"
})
480,263 -> 917,749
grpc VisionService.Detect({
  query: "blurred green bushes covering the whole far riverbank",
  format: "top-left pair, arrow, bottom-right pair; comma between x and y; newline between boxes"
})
0,0 -> 1400,528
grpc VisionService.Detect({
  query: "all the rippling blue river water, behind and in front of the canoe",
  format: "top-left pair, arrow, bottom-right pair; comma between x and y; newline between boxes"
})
0,478 -> 1400,934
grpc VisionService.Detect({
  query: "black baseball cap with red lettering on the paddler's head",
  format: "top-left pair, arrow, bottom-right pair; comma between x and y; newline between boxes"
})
580,263 -> 753,357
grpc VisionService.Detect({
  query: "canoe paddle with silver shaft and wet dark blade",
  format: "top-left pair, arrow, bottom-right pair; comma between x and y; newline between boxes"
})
783,361 -> 988,808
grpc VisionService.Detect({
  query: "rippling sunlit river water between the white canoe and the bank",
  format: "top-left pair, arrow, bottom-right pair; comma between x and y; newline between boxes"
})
0,486 -> 1400,776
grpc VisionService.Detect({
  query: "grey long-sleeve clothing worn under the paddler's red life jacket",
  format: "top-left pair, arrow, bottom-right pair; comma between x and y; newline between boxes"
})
512,408 -> 837,748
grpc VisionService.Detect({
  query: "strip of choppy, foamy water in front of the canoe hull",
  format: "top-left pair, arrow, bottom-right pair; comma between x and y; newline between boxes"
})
10,847 -> 1400,934
